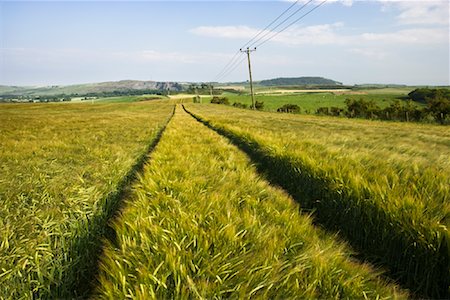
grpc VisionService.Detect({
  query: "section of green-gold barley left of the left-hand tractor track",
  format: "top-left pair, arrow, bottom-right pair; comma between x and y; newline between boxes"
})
0,102 -> 172,299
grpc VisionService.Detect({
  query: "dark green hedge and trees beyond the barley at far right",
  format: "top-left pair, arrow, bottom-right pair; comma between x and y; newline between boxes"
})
316,88 -> 450,124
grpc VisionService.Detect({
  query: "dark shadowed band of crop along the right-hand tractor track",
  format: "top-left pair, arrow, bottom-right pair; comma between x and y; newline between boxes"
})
183,106 -> 450,299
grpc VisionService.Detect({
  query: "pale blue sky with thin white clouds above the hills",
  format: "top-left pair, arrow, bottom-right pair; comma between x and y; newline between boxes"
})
0,0 -> 450,85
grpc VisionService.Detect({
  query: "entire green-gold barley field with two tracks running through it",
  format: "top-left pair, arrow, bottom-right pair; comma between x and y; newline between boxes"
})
0,99 -> 450,299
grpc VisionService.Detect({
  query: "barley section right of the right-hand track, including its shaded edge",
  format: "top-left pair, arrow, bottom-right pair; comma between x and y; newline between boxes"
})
187,104 -> 450,298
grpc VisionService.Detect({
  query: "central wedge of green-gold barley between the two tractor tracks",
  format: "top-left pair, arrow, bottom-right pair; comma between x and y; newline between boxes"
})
96,105 -> 406,299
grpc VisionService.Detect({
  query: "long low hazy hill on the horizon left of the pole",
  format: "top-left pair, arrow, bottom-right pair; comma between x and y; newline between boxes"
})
0,80 -> 182,96
